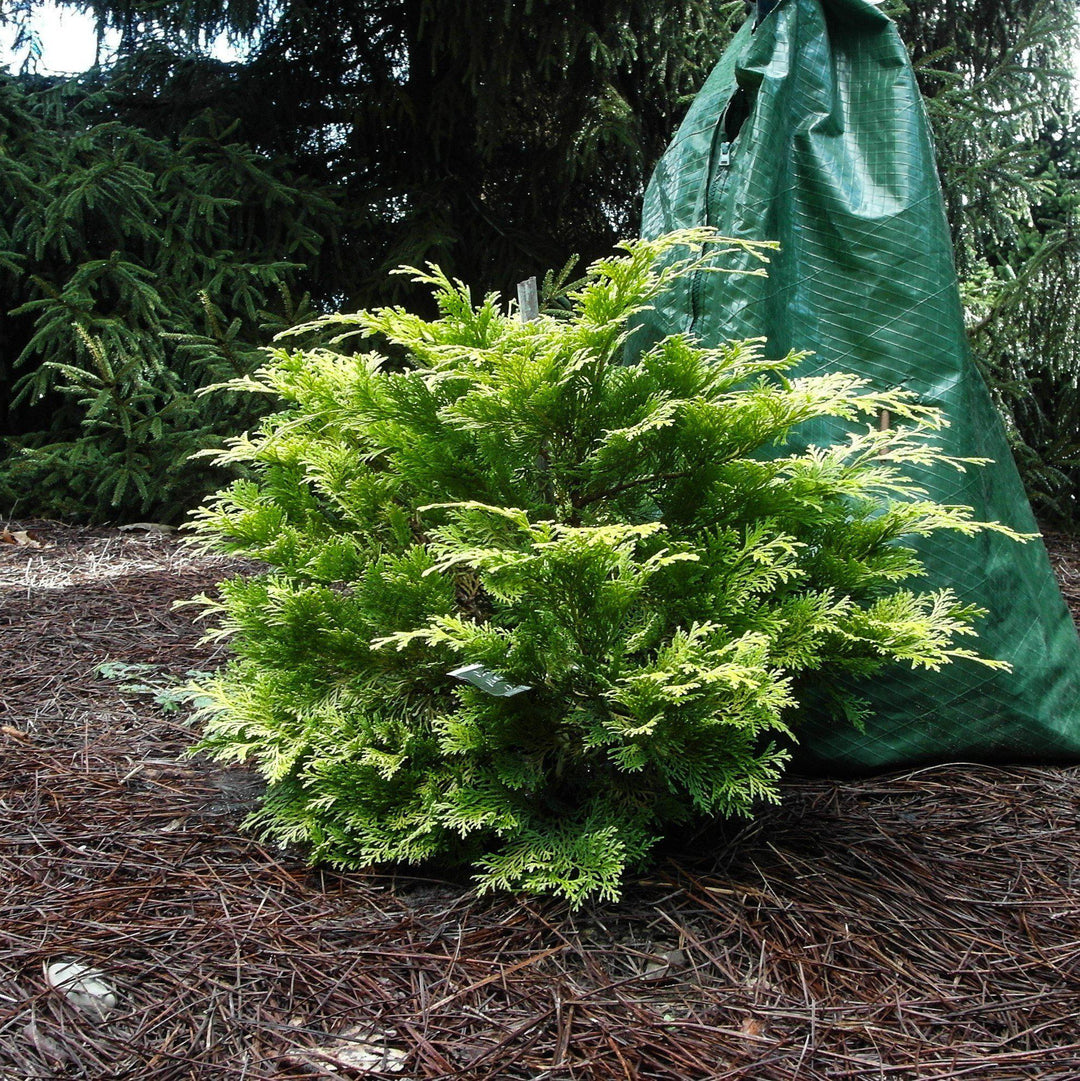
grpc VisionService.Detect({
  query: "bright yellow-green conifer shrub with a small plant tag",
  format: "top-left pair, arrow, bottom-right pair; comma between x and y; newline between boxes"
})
188,230 -> 1020,904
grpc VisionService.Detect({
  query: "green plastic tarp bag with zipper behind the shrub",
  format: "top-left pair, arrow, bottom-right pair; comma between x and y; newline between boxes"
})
636,0 -> 1080,773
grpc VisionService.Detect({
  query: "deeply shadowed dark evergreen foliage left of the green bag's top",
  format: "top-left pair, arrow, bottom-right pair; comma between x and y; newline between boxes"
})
46,0 -> 743,307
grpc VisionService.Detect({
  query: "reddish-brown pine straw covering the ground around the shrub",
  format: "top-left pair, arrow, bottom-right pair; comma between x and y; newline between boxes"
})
0,523 -> 1080,1081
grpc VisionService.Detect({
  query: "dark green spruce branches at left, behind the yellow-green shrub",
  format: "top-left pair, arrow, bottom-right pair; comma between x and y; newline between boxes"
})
0,77 -> 335,520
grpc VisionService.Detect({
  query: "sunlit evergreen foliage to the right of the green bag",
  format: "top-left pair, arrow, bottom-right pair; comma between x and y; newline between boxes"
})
894,0 -> 1080,522
